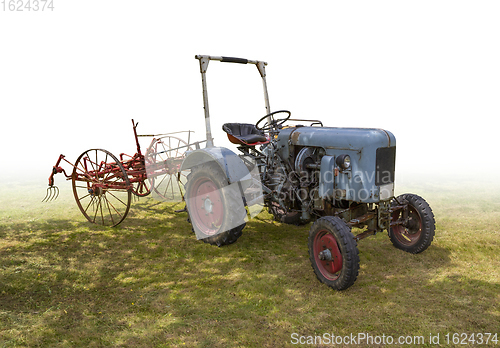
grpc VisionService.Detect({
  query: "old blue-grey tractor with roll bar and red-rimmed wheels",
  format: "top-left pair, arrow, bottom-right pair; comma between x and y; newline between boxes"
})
181,55 -> 435,290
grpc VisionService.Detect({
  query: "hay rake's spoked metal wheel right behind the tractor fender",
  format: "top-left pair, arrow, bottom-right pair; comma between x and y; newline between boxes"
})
145,136 -> 192,201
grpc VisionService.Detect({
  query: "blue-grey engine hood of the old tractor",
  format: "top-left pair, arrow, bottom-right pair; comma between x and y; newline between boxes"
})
277,127 -> 396,203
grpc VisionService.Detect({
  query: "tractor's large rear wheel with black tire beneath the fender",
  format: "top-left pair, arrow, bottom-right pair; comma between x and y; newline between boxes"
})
185,162 -> 246,247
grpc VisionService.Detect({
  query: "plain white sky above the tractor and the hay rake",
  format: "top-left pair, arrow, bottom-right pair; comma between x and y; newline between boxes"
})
0,0 -> 500,185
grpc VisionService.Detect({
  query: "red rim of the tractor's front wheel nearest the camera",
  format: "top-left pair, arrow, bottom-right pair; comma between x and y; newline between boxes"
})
313,230 -> 343,280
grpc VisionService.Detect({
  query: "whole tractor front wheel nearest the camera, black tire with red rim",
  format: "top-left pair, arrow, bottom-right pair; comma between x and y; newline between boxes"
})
308,216 -> 359,290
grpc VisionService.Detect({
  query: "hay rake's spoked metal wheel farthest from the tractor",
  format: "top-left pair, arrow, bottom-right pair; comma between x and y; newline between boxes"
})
72,149 -> 131,226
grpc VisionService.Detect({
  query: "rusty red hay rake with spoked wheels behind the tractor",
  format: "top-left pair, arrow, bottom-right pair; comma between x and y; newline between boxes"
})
42,120 -> 199,226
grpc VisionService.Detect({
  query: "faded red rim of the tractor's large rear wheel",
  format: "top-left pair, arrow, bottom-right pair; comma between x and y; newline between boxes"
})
189,178 -> 224,236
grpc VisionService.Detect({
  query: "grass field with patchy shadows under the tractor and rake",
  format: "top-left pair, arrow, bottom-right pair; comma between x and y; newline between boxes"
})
0,178 -> 500,348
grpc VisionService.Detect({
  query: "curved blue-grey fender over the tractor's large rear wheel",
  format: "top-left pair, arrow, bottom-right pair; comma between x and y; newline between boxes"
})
181,147 -> 252,190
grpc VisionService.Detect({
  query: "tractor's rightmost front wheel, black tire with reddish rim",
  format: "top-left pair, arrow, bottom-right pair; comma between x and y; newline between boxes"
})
389,193 -> 436,254
